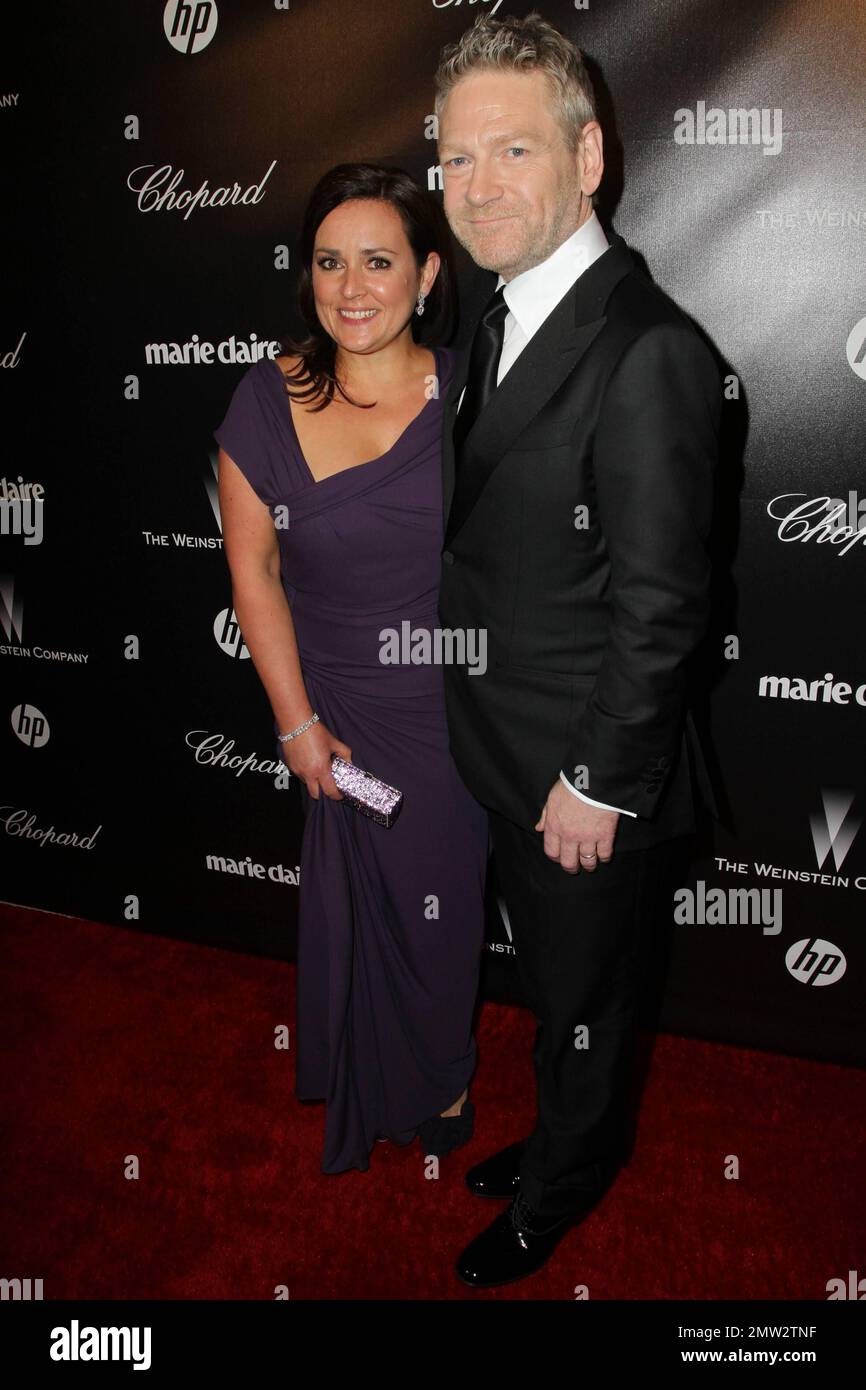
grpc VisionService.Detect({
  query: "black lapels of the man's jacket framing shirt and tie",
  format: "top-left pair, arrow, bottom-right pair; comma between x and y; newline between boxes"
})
442,232 -> 634,546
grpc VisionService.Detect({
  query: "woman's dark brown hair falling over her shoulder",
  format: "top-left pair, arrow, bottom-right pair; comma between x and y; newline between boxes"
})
279,164 -> 456,410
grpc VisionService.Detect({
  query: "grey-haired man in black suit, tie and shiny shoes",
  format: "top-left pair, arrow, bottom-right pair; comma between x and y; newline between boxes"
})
436,14 -> 721,1286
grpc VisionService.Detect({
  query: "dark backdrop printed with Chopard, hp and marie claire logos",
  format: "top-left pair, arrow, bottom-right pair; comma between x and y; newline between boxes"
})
0,0 -> 866,1063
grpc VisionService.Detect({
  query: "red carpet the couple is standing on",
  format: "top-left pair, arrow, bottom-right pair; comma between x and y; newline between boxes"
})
0,908 -> 866,1300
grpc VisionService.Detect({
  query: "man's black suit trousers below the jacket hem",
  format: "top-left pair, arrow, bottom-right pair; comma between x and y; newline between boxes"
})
491,812 -> 677,1222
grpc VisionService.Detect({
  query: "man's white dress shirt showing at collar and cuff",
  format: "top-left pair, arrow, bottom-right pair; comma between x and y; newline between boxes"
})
457,211 -> 637,819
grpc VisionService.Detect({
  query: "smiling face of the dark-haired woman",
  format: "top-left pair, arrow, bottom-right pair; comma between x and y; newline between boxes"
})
313,197 -> 439,353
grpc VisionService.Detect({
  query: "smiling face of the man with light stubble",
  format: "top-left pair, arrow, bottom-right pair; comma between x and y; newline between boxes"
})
438,71 -> 601,281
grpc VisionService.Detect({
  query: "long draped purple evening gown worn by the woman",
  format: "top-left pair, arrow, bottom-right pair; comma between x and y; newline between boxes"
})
214,349 -> 488,1173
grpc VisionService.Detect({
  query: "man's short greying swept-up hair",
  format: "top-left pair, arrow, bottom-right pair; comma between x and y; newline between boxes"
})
434,10 -> 598,150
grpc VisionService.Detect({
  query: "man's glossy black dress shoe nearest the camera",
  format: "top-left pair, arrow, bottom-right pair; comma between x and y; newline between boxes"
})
455,1193 -> 599,1289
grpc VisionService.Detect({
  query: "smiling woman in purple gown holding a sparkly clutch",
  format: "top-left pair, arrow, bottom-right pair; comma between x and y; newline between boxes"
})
214,165 -> 488,1173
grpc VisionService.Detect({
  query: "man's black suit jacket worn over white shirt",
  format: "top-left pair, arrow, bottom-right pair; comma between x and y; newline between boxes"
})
439,234 -> 721,849
